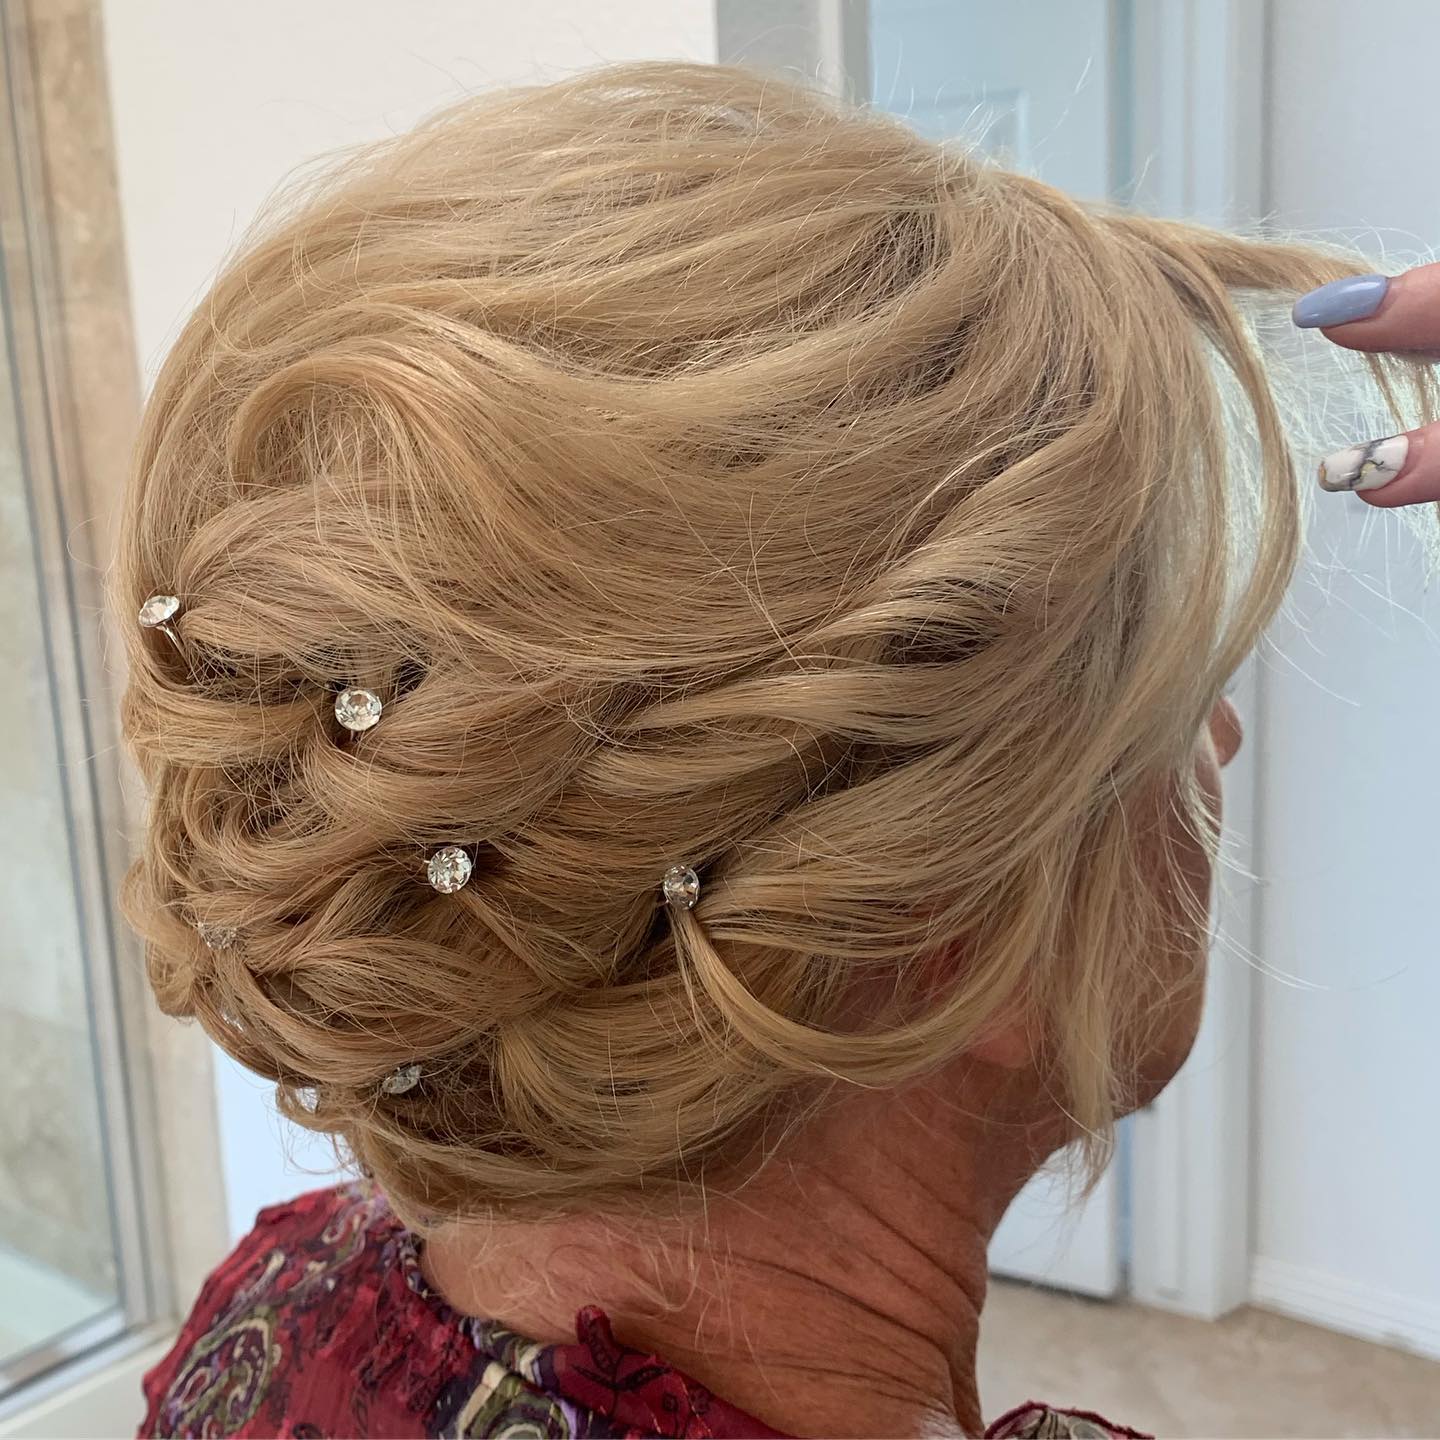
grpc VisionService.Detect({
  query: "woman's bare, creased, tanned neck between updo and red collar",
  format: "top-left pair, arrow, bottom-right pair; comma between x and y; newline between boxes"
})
425,1079 -> 1048,1436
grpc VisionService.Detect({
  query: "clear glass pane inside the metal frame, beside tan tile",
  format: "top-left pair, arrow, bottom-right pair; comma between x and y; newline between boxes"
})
0,298 -> 120,1380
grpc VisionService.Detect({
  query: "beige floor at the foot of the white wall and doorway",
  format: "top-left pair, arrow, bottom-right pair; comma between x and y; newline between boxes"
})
979,1282 -> 1440,1440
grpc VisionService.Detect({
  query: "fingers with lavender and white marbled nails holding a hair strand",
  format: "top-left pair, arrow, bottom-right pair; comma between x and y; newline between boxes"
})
1293,265 -> 1440,508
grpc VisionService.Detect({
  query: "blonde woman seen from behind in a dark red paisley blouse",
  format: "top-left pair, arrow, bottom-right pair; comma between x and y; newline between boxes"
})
118,66 -> 1428,1436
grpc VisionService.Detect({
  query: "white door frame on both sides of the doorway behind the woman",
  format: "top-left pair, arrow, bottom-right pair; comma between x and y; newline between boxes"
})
716,0 -> 1269,1319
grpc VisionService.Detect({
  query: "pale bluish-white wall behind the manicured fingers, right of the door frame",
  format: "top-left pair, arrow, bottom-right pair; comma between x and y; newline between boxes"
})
1250,0 -> 1440,1355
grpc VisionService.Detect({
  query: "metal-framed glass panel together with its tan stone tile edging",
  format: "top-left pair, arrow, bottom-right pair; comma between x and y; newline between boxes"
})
0,4 -> 167,1411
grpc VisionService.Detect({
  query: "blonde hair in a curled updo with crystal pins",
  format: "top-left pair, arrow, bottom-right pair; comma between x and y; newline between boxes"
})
115,65 -> 1428,1217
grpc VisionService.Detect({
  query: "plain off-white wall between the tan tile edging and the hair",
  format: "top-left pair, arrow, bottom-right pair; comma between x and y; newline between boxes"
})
104,0 -> 716,1234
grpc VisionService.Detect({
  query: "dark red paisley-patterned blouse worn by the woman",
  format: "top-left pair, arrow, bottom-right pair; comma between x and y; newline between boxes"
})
138,1184 -> 1135,1440
